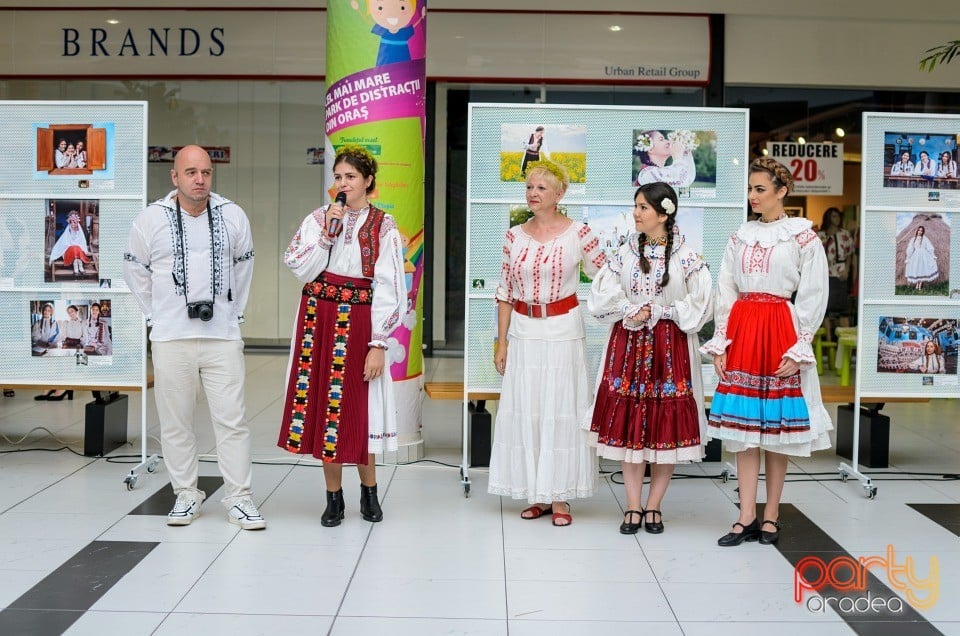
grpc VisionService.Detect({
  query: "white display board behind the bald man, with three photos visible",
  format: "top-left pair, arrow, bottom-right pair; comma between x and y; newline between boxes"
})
0,101 -> 147,389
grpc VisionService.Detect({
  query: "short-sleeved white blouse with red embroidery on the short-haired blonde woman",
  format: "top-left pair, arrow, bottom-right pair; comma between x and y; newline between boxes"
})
496,221 -> 606,341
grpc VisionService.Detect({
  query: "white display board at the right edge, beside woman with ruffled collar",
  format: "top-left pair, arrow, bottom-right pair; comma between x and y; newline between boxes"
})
854,113 -> 960,398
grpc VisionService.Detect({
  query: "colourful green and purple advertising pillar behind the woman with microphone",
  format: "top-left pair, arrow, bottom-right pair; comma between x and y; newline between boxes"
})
325,0 -> 427,446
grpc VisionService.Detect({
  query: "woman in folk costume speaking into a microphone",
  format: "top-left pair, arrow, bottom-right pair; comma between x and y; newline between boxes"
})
278,145 -> 407,527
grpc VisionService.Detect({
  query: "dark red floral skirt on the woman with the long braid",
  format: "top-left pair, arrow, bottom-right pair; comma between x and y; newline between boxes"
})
590,320 -> 700,459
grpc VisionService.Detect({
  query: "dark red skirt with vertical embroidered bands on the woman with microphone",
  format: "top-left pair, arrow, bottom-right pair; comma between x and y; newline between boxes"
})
278,273 -> 373,464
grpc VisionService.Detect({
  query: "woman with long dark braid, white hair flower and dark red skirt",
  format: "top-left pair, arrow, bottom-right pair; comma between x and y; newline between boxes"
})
589,182 -> 712,534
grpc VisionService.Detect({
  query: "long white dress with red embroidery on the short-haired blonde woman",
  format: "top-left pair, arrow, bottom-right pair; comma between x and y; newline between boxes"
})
488,221 -> 605,503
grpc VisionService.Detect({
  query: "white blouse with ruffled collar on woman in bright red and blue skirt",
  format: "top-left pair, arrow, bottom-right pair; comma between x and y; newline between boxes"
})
701,218 -> 827,366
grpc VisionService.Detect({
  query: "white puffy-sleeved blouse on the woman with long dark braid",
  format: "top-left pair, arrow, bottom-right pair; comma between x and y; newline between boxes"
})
587,227 -> 713,334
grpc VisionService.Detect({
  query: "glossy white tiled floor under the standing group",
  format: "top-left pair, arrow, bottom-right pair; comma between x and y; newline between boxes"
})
0,353 -> 960,636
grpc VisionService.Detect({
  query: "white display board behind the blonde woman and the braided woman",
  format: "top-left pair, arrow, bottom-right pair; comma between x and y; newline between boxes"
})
461,104 -> 749,481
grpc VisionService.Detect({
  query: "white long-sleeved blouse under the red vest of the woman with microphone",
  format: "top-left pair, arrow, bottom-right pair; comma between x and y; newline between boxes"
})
283,205 -> 407,345
